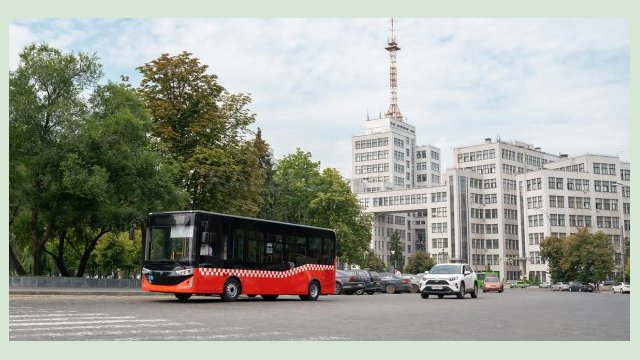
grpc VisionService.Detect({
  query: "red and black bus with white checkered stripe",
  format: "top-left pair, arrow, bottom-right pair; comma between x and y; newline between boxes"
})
142,211 -> 336,301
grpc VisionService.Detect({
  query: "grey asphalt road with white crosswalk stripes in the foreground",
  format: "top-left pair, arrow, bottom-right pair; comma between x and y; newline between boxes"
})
9,288 -> 630,341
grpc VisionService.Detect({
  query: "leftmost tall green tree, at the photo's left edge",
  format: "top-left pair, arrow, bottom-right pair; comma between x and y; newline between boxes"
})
9,45 -> 102,275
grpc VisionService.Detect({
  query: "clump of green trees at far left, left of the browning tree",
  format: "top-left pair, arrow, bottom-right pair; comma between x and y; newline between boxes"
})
9,45 -> 181,276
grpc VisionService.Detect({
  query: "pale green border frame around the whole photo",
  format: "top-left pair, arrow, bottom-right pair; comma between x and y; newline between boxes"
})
0,0 -> 640,359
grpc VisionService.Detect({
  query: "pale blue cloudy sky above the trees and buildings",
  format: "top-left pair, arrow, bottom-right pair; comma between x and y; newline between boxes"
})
9,18 -> 630,177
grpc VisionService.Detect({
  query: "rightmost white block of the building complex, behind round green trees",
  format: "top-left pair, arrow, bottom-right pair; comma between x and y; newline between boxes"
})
517,155 -> 631,281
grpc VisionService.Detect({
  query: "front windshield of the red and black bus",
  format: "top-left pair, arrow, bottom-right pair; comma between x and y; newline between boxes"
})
145,214 -> 195,265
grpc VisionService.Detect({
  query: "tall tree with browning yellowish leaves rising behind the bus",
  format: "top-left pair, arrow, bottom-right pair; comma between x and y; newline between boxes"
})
138,52 -> 268,216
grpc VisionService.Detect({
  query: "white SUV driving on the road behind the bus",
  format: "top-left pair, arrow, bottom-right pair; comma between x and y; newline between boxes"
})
420,263 -> 478,299
